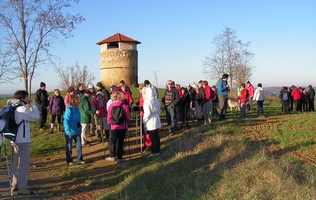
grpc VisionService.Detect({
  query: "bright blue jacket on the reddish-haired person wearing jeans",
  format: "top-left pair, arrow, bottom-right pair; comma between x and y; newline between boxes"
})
64,105 -> 81,136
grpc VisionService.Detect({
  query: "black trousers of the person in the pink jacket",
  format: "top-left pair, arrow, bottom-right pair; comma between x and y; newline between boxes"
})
109,129 -> 126,159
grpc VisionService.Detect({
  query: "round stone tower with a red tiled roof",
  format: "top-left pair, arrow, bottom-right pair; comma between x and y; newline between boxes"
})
97,33 -> 140,86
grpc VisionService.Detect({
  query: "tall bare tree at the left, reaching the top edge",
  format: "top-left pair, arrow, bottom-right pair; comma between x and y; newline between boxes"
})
0,0 -> 84,93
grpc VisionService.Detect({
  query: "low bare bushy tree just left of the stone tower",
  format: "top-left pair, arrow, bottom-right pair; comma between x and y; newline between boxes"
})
55,62 -> 95,90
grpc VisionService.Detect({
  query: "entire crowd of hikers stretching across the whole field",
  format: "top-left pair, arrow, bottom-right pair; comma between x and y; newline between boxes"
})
1,74 -> 315,194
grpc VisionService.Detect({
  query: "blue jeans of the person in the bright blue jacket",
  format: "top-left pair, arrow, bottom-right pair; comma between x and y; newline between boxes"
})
65,135 -> 83,163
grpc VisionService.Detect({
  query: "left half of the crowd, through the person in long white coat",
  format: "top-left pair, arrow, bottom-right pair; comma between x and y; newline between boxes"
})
8,80 -> 161,195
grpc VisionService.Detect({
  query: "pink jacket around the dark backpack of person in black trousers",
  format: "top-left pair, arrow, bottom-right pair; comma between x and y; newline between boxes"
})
108,101 -> 131,130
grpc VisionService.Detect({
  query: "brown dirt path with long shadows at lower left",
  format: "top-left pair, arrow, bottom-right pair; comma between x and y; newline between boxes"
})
0,125 -> 157,199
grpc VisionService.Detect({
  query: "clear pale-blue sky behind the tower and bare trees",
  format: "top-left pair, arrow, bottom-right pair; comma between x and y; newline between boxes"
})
0,0 -> 316,93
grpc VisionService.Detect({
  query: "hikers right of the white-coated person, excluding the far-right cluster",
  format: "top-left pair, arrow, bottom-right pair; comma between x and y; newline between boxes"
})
162,74 -> 265,131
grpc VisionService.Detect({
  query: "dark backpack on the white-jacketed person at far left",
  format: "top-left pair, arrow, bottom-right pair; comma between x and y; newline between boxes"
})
0,105 -> 24,141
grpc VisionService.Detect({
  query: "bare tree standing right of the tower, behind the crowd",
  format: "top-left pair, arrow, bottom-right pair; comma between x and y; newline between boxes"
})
202,27 -> 254,87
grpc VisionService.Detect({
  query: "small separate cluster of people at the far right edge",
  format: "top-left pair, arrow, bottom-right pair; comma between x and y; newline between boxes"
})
279,85 -> 315,113
